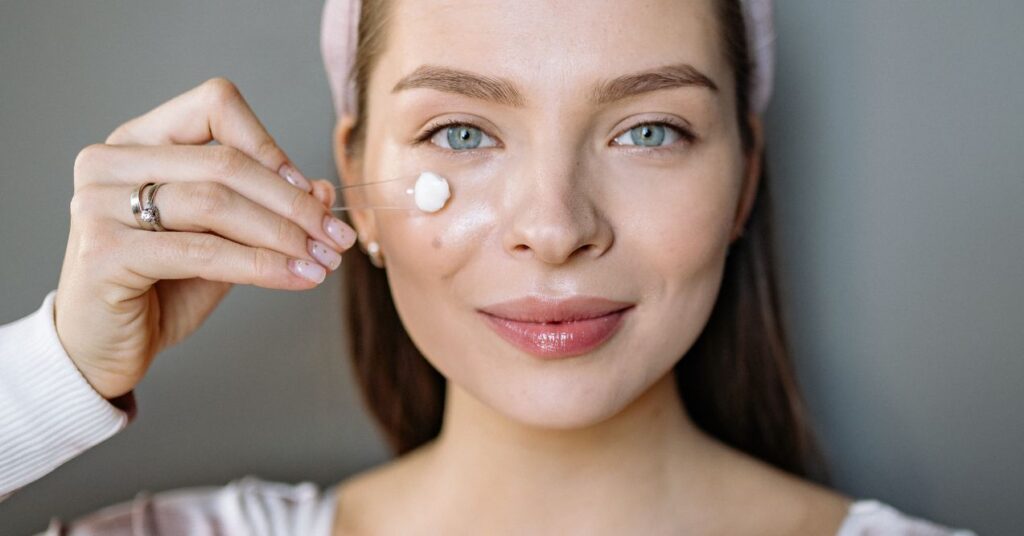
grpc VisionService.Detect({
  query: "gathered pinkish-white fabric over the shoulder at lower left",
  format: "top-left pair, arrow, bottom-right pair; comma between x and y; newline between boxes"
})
39,476 -> 335,536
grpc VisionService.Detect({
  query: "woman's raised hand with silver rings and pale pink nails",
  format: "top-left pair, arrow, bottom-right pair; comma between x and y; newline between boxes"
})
54,78 -> 355,399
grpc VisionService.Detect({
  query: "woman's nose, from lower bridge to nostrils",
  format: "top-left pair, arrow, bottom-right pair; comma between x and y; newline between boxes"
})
503,147 -> 614,264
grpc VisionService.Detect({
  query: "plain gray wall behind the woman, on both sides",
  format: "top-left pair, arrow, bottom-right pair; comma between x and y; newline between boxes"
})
0,0 -> 1024,535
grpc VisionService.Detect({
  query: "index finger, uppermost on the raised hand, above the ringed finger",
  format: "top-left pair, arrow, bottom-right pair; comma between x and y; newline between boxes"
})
105,77 -> 313,193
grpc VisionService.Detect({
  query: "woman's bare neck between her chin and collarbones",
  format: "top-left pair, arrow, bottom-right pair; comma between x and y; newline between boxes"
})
428,372 -> 729,526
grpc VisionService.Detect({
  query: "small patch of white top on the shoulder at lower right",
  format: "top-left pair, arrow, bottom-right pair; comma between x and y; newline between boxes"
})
836,499 -> 977,536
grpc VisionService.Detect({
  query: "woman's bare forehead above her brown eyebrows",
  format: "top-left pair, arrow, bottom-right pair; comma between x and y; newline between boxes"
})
381,0 -> 727,105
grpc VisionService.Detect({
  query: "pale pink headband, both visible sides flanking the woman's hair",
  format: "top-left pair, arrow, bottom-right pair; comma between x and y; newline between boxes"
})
321,0 -> 775,116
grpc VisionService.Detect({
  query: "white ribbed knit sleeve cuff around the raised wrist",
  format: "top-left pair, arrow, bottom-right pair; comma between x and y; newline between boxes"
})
0,289 -> 136,501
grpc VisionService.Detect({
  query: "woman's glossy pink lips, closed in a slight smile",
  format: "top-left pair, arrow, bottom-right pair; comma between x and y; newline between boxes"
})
479,296 -> 633,358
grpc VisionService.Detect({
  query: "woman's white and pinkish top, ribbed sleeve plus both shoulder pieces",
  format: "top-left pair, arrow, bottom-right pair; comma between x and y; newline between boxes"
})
0,290 -> 977,536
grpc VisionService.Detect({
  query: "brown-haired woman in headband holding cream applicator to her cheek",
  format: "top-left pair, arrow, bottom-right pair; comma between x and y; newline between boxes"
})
0,0 -> 970,535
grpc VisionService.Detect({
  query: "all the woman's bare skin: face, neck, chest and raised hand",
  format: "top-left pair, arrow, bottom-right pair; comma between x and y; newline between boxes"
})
46,0 -> 849,534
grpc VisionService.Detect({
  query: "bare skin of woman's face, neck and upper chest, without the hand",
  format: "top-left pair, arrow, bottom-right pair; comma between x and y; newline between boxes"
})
335,0 -> 851,535
